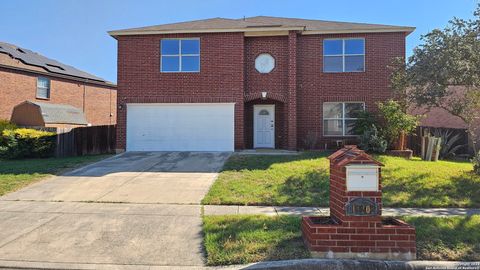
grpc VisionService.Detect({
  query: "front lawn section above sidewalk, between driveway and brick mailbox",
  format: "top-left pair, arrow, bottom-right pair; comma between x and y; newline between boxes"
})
203,152 -> 329,206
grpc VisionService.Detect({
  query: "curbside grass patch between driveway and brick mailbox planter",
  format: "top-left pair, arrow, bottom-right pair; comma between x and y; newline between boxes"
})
203,215 -> 309,265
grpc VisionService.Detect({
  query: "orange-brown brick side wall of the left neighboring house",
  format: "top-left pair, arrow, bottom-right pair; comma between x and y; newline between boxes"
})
0,54 -> 117,126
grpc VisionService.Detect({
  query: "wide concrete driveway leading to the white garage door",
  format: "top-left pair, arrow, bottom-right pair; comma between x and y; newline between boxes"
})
0,152 -> 229,269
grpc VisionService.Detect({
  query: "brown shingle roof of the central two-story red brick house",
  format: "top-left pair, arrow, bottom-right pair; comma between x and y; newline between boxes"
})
109,16 -> 415,36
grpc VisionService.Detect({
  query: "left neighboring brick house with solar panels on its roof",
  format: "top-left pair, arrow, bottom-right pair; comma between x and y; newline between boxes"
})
0,42 -> 117,128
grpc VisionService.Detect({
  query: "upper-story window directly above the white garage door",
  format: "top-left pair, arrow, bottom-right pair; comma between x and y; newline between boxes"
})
161,39 -> 200,72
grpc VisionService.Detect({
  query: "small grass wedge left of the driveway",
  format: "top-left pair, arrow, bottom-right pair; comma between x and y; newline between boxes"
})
0,155 -> 110,196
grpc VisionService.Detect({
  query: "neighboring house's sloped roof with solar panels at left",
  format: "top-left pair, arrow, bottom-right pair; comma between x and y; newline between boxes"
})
0,42 -> 113,83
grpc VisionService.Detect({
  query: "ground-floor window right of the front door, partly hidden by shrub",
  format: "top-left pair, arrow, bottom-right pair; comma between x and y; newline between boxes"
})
323,102 -> 365,136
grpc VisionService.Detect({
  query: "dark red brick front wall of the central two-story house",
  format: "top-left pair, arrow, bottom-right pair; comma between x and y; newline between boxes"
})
116,31 -> 406,152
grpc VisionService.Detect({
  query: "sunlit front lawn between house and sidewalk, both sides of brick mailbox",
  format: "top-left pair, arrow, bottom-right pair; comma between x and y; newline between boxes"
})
202,152 -> 480,207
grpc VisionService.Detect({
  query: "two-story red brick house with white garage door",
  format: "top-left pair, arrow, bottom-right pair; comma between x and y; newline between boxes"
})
109,16 -> 414,151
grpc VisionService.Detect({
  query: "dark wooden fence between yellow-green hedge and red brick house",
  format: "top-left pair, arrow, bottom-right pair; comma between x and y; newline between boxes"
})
55,125 -> 116,157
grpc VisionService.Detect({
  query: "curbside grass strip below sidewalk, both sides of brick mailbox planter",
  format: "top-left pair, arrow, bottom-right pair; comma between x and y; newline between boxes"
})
203,215 -> 480,265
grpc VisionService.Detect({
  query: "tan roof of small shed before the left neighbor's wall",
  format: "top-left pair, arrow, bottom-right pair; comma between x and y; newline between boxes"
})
15,101 -> 88,125
